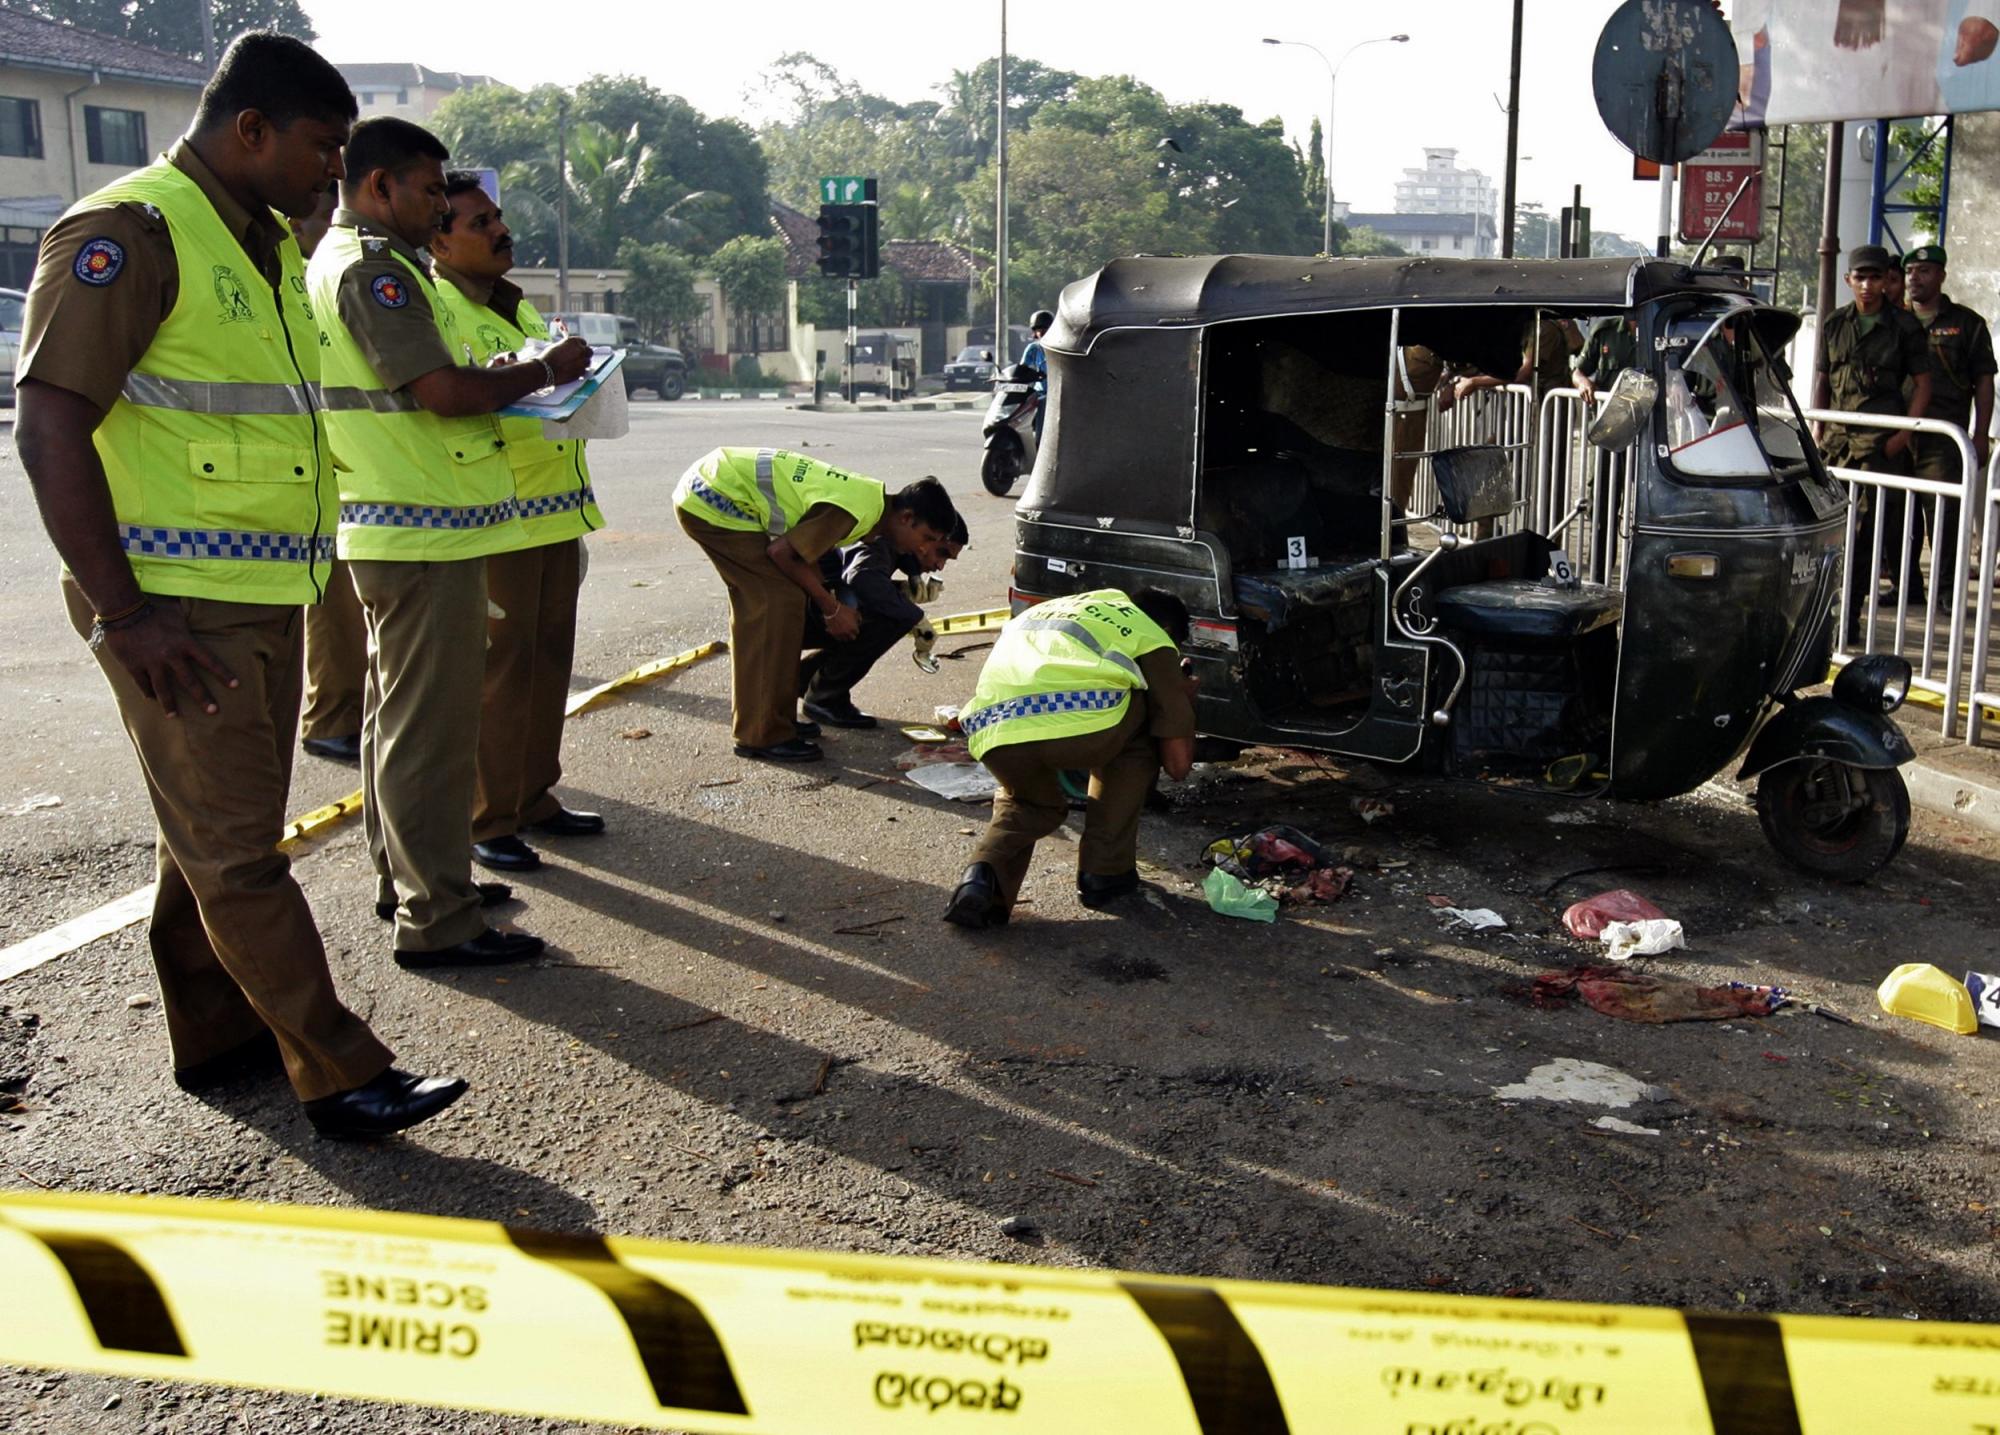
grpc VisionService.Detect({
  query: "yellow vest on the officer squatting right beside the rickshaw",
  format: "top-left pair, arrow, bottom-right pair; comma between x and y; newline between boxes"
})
958,588 -> 1174,759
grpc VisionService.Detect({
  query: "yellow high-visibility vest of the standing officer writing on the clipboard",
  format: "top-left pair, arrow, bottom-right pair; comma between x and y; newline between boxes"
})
306,224 -> 526,562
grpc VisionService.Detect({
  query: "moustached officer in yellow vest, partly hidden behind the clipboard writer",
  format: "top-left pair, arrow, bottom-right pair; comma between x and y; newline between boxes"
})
430,170 -> 604,871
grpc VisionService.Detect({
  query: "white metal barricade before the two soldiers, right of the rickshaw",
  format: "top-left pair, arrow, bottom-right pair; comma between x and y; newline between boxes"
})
1806,408 -> 1968,737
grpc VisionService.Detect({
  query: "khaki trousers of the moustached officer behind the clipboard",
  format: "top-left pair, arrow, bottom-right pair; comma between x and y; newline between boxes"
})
472,538 -> 584,841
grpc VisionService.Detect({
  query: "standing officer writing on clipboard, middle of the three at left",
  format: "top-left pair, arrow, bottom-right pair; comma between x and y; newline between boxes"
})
306,116 -> 590,967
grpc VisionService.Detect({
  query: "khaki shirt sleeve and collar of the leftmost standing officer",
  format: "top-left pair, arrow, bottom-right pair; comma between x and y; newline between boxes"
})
16,140 -> 290,410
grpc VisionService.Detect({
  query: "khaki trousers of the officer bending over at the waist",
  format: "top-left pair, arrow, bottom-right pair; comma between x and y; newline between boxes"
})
678,512 -> 806,747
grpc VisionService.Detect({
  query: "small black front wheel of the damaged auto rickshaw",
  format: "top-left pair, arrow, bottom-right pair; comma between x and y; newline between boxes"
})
1756,757 -> 1910,881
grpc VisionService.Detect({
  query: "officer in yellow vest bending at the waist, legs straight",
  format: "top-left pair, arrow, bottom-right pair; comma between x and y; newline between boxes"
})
674,448 -> 958,761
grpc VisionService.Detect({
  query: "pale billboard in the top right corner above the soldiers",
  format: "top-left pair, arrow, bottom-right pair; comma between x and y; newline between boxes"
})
1730,0 -> 2000,126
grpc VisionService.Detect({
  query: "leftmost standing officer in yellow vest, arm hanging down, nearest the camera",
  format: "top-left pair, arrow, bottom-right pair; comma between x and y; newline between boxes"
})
14,34 -> 466,1137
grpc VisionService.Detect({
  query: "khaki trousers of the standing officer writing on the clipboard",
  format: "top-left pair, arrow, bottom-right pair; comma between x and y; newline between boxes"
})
348,558 -> 486,951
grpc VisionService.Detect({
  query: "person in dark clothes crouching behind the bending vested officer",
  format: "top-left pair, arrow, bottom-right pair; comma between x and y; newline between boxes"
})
798,516 -> 970,727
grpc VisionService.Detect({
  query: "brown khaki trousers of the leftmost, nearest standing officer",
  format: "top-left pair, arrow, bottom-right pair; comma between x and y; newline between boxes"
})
62,578 -> 390,1101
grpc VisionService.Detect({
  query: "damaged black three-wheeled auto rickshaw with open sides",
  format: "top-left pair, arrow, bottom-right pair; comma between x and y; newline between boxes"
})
1012,256 -> 1914,879
